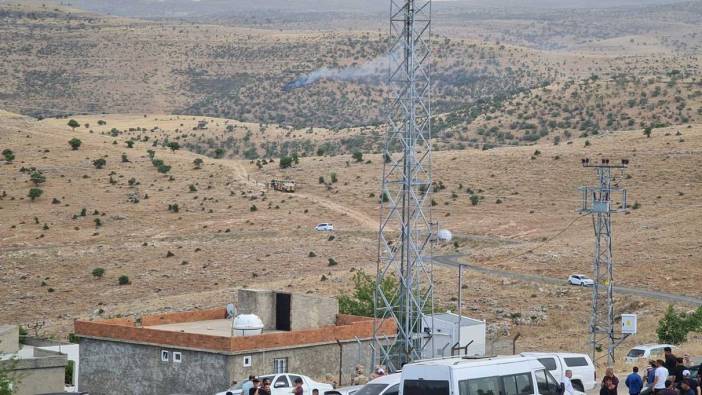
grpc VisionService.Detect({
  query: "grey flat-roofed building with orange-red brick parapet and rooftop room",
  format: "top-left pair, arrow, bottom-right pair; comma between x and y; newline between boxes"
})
75,290 -> 395,394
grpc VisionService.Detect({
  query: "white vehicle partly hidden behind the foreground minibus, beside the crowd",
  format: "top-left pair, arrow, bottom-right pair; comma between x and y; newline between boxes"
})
519,352 -> 597,392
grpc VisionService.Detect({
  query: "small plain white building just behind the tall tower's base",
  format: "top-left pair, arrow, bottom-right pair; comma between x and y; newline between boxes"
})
423,312 -> 485,358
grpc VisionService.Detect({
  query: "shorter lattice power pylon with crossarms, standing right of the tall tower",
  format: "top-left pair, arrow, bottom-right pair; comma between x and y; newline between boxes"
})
578,159 -> 629,366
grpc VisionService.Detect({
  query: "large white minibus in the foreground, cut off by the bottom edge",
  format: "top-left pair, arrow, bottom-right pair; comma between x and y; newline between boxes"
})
400,356 -> 560,395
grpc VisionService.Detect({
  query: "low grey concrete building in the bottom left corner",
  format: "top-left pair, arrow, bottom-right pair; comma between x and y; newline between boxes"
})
0,325 -> 66,395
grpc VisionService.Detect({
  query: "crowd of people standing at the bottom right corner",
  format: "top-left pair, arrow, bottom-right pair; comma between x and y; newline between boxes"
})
588,347 -> 702,395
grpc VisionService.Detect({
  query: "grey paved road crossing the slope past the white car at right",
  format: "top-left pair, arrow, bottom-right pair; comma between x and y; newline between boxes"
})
433,255 -> 702,306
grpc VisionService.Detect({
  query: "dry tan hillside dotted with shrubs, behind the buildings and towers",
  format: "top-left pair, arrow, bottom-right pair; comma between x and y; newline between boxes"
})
0,113 -> 702,358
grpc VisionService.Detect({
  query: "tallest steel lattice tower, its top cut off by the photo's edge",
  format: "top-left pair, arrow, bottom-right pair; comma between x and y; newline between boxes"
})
373,0 -> 433,371
